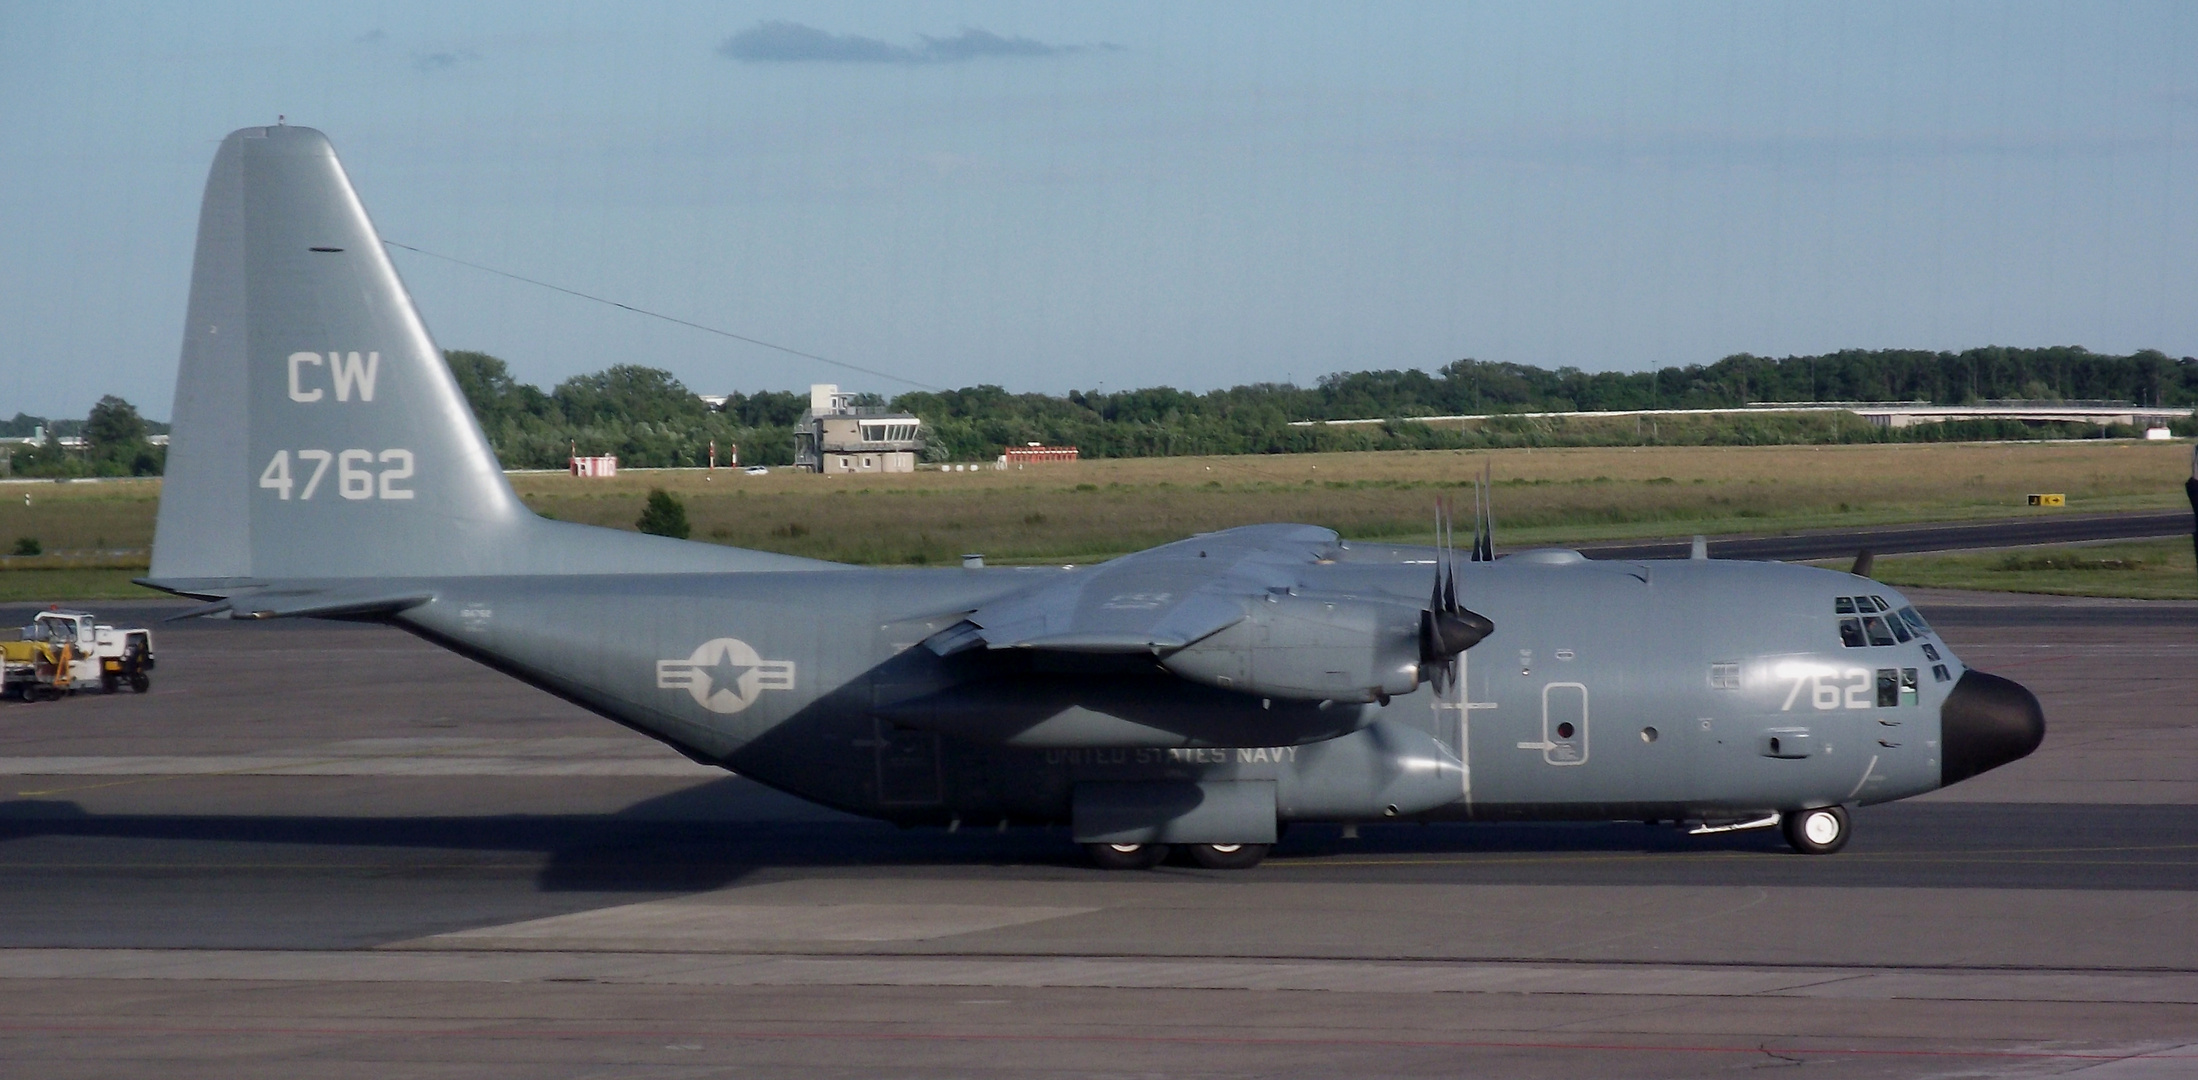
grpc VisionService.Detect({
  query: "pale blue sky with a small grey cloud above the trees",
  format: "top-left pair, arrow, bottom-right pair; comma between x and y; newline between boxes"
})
0,0 -> 2198,418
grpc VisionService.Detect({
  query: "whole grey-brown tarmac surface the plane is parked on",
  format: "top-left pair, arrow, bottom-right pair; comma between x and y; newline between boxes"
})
0,589 -> 2198,1080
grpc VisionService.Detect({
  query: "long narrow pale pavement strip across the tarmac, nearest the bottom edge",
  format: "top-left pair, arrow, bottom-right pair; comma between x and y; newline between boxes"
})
0,948 -> 2198,1011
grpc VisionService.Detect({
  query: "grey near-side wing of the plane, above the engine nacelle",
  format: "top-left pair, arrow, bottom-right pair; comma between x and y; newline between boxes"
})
928,526 -> 1336,655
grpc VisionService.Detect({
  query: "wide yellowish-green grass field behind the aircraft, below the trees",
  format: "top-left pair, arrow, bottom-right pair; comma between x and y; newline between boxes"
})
0,440 -> 2191,600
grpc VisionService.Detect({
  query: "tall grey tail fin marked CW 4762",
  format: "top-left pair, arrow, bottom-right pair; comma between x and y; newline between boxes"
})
149,128 -> 824,592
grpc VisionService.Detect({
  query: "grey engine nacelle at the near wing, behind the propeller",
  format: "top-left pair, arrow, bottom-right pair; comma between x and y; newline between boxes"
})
1161,592 -> 1422,702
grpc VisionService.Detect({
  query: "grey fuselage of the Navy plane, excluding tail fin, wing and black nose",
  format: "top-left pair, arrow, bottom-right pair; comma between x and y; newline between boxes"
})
398,545 -> 1965,823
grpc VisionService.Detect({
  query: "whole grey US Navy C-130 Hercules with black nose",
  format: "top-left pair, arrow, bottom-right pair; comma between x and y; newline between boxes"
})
145,125 -> 2044,867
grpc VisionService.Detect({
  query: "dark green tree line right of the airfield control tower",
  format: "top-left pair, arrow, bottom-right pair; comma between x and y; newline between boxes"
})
892,348 -> 2198,460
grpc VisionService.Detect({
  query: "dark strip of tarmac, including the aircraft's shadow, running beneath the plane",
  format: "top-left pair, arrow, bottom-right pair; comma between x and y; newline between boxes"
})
0,776 -> 2198,891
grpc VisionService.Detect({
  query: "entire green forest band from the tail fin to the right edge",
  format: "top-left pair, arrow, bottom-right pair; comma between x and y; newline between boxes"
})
446,348 -> 2198,469
